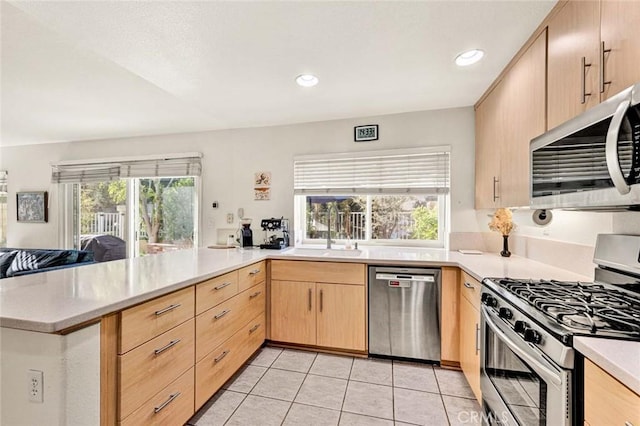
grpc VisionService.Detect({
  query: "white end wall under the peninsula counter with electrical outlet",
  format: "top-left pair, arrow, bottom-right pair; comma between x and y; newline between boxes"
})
0,324 -> 100,426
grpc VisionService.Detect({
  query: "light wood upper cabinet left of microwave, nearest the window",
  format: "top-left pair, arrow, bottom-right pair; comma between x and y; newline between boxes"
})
476,30 -> 547,209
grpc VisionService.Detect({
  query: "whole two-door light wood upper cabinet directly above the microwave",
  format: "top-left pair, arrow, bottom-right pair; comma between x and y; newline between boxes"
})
547,0 -> 640,129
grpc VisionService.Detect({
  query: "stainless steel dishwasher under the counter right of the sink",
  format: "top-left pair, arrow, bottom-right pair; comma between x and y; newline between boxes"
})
369,266 -> 441,362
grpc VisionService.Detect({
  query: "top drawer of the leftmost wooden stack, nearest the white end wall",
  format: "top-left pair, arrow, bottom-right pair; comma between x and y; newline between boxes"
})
118,287 -> 194,354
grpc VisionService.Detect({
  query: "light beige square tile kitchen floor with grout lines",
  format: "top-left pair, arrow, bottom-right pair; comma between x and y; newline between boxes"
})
187,347 -> 480,426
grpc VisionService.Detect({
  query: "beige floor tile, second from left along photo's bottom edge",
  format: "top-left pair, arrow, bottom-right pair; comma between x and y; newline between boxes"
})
225,395 -> 291,426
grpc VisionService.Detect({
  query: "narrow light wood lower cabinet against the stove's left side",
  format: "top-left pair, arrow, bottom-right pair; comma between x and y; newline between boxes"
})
459,272 -> 482,401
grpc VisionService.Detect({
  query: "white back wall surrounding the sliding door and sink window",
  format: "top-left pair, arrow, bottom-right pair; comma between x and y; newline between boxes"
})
0,107 -> 478,247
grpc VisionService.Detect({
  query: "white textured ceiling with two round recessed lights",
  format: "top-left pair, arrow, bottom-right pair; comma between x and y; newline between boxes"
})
0,0 -> 555,145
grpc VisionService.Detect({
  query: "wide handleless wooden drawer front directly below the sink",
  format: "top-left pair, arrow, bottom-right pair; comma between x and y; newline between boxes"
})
271,260 -> 366,285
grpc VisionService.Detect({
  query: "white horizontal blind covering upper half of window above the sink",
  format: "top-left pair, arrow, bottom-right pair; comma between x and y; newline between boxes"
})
293,147 -> 449,195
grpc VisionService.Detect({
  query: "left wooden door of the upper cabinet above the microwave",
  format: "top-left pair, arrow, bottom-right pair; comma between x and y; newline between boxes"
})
547,1 -> 600,129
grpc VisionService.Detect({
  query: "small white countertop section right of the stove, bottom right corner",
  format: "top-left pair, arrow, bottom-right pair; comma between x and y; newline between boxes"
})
573,337 -> 640,395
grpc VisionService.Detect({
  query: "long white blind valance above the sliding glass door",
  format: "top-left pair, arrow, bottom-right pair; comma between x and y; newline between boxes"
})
51,154 -> 202,183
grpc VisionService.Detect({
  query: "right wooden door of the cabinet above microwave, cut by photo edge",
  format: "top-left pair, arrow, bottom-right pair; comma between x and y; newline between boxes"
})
600,0 -> 640,100
